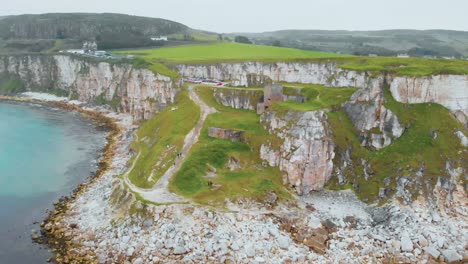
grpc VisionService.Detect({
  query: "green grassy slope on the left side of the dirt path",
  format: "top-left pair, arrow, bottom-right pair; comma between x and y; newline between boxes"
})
129,90 -> 200,188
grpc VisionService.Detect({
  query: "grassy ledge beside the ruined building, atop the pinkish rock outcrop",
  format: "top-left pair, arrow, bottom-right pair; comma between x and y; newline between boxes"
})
272,83 -> 357,113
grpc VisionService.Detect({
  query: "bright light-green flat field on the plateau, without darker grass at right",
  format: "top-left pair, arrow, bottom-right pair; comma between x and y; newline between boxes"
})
117,42 -> 343,64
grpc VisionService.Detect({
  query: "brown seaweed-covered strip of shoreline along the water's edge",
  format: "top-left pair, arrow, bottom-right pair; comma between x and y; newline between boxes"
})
0,95 -> 123,263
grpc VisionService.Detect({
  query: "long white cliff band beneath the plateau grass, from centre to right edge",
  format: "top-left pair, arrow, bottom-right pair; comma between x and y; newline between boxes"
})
176,62 -> 468,123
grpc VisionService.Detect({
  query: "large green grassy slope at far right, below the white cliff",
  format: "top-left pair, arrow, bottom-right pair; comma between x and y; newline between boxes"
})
328,84 -> 468,202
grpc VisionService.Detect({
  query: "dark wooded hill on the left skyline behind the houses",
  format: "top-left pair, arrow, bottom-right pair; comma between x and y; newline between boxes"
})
0,13 -> 190,49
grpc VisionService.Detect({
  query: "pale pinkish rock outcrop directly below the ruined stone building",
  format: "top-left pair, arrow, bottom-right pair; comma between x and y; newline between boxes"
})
260,111 -> 335,194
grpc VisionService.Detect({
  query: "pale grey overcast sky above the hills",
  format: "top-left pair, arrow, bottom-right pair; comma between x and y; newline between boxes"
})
0,0 -> 468,33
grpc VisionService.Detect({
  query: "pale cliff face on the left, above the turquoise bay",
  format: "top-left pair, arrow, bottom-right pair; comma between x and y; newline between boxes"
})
0,55 -> 180,120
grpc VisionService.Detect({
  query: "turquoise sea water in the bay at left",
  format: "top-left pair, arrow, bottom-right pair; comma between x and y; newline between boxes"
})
0,102 -> 105,263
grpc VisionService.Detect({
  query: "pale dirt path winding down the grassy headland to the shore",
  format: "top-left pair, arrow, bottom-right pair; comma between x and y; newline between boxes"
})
124,86 -> 216,203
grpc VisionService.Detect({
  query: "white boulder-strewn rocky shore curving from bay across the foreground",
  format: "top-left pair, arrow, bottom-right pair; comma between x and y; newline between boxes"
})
2,92 -> 468,264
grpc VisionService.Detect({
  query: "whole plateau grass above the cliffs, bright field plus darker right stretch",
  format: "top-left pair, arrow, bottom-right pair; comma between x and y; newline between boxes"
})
117,42 -> 468,76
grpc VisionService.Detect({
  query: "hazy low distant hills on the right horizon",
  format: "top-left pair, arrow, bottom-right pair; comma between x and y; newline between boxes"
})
233,30 -> 468,57
